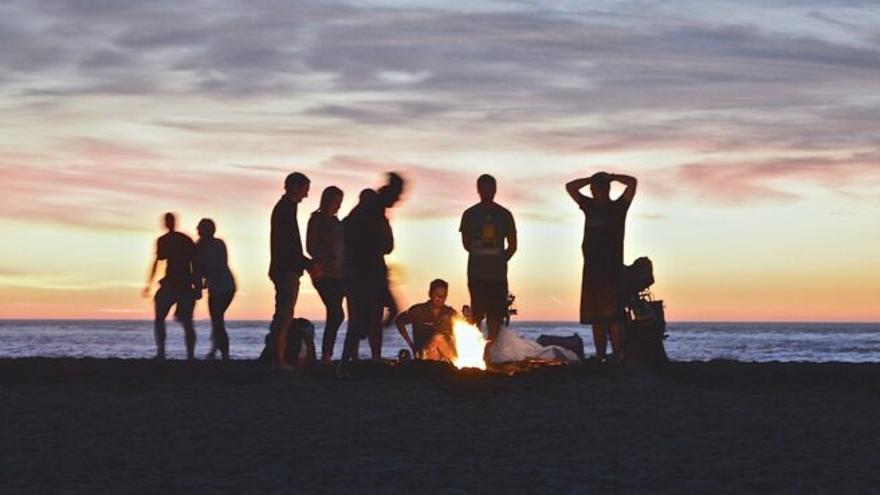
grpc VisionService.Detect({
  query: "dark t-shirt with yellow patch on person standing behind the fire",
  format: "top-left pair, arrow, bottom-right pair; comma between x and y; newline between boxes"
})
459,202 -> 516,281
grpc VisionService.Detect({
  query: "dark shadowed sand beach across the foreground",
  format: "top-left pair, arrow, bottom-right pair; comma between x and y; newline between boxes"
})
0,359 -> 880,493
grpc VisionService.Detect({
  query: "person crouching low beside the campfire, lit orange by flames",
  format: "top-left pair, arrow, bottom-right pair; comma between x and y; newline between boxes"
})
394,278 -> 458,362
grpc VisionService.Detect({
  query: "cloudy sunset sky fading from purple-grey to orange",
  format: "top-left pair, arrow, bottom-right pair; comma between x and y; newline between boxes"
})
0,0 -> 880,321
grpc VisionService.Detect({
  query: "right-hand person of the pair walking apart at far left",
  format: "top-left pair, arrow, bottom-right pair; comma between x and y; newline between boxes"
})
193,218 -> 235,359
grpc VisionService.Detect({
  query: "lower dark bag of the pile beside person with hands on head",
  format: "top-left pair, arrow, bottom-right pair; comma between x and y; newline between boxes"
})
623,296 -> 669,367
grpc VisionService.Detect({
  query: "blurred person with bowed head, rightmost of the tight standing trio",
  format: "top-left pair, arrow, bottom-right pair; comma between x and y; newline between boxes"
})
342,173 -> 403,363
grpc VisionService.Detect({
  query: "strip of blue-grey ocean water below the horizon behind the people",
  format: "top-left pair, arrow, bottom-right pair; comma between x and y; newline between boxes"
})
0,318 -> 880,363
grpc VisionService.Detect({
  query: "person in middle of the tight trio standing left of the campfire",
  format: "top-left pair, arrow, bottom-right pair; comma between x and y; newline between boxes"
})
306,186 -> 345,363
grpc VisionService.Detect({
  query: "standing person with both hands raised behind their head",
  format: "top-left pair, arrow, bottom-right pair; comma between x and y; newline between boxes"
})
565,172 -> 637,360
